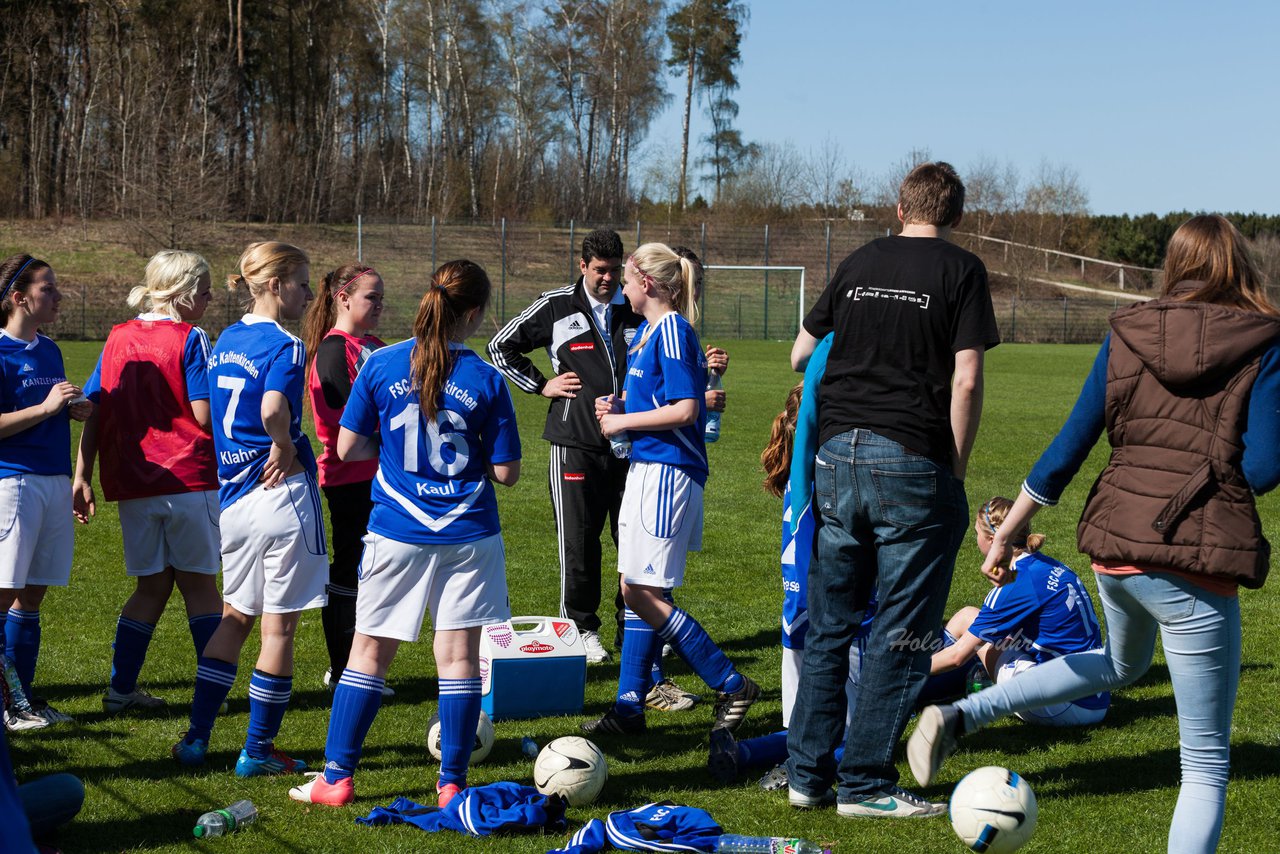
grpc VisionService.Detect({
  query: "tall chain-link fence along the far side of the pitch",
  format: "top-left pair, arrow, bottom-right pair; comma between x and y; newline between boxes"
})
37,220 -> 1141,342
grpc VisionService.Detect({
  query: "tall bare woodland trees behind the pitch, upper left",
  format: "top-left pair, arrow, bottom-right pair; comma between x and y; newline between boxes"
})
0,0 -> 746,222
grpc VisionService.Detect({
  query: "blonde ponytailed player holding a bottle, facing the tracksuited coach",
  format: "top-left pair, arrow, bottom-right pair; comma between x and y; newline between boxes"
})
582,243 -> 760,735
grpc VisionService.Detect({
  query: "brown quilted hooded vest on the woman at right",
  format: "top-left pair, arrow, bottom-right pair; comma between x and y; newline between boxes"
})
1076,283 -> 1280,588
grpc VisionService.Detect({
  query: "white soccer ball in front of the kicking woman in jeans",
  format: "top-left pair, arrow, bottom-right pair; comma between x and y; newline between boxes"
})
951,766 -> 1038,854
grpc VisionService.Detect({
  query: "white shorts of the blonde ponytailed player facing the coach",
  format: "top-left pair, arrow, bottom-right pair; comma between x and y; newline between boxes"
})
618,462 -> 703,589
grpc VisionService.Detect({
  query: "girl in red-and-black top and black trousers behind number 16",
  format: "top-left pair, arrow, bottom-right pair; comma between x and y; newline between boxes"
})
303,264 -> 394,697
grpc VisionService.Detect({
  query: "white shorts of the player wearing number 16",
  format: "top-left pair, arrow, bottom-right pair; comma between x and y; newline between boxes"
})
356,533 -> 511,641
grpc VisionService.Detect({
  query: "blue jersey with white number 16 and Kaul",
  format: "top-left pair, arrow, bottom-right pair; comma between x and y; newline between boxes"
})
339,341 -> 520,543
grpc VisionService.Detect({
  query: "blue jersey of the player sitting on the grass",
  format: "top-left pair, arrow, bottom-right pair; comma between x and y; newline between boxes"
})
969,552 -> 1102,663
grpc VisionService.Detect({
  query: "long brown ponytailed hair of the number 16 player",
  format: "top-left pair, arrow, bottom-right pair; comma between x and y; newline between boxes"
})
411,260 -> 490,421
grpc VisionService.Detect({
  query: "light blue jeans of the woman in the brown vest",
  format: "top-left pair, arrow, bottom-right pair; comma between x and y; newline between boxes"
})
956,572 -> 1240,854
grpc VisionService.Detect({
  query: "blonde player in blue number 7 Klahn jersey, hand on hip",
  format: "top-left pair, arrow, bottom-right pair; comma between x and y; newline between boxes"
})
173,242 -> 329,777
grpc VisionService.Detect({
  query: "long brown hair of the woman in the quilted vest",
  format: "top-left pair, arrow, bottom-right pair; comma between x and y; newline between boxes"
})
1164,214 -> 1280,315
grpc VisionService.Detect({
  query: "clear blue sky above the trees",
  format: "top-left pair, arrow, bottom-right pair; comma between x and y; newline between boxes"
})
649,0 -> 1280,214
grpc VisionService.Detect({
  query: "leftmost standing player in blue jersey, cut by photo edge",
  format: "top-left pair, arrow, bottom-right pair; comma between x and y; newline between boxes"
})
0,255 -> 92,729
